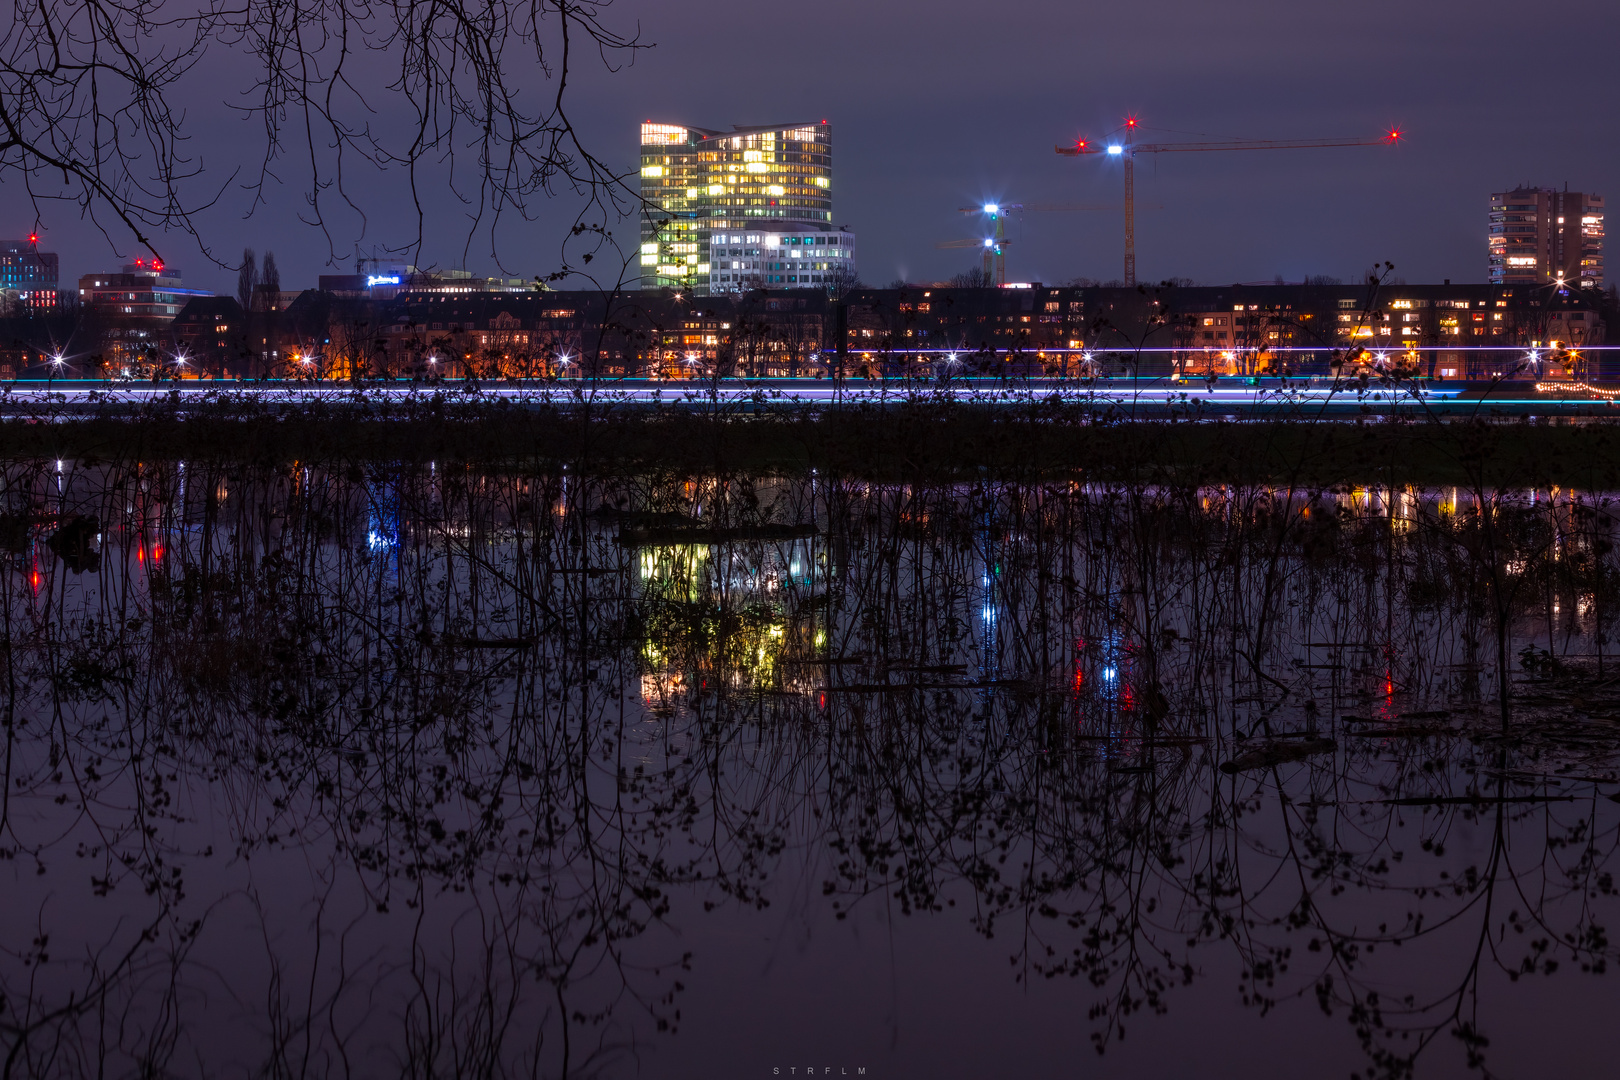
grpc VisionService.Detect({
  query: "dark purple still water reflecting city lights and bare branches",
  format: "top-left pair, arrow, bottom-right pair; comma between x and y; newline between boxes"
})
0,461 -> 1620,1078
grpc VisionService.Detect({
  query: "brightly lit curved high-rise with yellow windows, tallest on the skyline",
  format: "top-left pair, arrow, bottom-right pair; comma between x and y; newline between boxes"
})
642,120 -> 855,296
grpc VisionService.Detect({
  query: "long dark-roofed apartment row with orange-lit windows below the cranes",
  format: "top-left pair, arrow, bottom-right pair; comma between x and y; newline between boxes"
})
847,282 -> 1620,381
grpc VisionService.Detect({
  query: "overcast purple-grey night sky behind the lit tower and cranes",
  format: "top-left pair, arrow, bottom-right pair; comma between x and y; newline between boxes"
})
5,0 -> 1620,291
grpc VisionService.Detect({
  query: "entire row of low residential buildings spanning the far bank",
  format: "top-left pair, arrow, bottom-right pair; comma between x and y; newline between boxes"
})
0,275 -> 1620,381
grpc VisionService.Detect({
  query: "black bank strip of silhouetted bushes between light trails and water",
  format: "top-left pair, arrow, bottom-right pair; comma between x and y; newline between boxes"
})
0,402 -> 1620,489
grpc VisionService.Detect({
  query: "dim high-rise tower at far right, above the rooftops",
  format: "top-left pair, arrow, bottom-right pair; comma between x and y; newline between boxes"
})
1490,188 -> 1604,288
